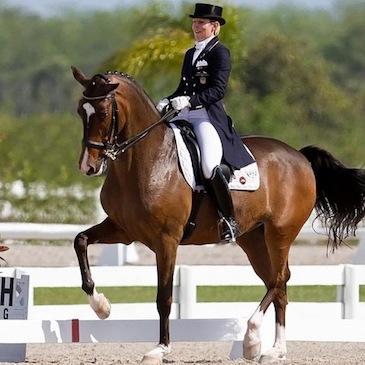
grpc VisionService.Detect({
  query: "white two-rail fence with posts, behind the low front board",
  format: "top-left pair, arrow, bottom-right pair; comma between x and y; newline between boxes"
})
0,265 -> 365,320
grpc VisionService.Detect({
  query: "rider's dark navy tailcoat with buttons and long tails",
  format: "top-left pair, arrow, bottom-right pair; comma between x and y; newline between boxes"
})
168,37 -> 253,169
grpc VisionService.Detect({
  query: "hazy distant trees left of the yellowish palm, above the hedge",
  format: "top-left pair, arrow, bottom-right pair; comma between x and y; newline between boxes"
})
0,4 -> 132,116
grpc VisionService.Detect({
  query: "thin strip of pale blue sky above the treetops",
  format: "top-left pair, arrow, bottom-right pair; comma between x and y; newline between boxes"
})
0,0 -> 336,16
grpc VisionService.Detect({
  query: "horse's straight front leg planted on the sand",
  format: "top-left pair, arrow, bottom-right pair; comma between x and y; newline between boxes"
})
142,243 -> 177,365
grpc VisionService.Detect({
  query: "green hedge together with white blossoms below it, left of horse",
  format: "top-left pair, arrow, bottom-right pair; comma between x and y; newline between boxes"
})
0,114 -> 102,224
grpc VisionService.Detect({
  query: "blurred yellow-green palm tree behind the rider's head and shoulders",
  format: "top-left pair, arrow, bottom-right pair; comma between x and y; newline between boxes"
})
102,3 -> 245,102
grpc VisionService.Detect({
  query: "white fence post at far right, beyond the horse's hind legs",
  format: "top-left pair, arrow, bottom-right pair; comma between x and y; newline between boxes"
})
343,265 -> 360,319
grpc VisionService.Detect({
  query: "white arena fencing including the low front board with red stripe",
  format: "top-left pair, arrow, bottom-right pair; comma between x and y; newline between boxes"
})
0,265 -> 365,357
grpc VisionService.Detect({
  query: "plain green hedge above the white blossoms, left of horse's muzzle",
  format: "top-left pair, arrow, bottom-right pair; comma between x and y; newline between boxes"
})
0,113 -> 100,188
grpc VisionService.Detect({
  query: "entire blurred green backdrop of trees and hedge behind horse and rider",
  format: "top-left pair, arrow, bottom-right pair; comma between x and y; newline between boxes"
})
0,0 -> 365,222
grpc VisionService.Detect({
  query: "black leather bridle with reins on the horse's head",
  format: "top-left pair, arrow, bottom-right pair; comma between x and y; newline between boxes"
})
82,75 -> 176,161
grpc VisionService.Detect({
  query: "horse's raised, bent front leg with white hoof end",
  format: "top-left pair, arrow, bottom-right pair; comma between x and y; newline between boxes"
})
74,218 -> 130,319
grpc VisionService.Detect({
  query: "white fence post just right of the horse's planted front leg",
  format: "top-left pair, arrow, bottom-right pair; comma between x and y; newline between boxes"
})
179,265 -> 197,319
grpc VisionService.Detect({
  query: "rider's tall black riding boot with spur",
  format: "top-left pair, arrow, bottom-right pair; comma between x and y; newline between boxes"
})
209,166 -> 239,243
